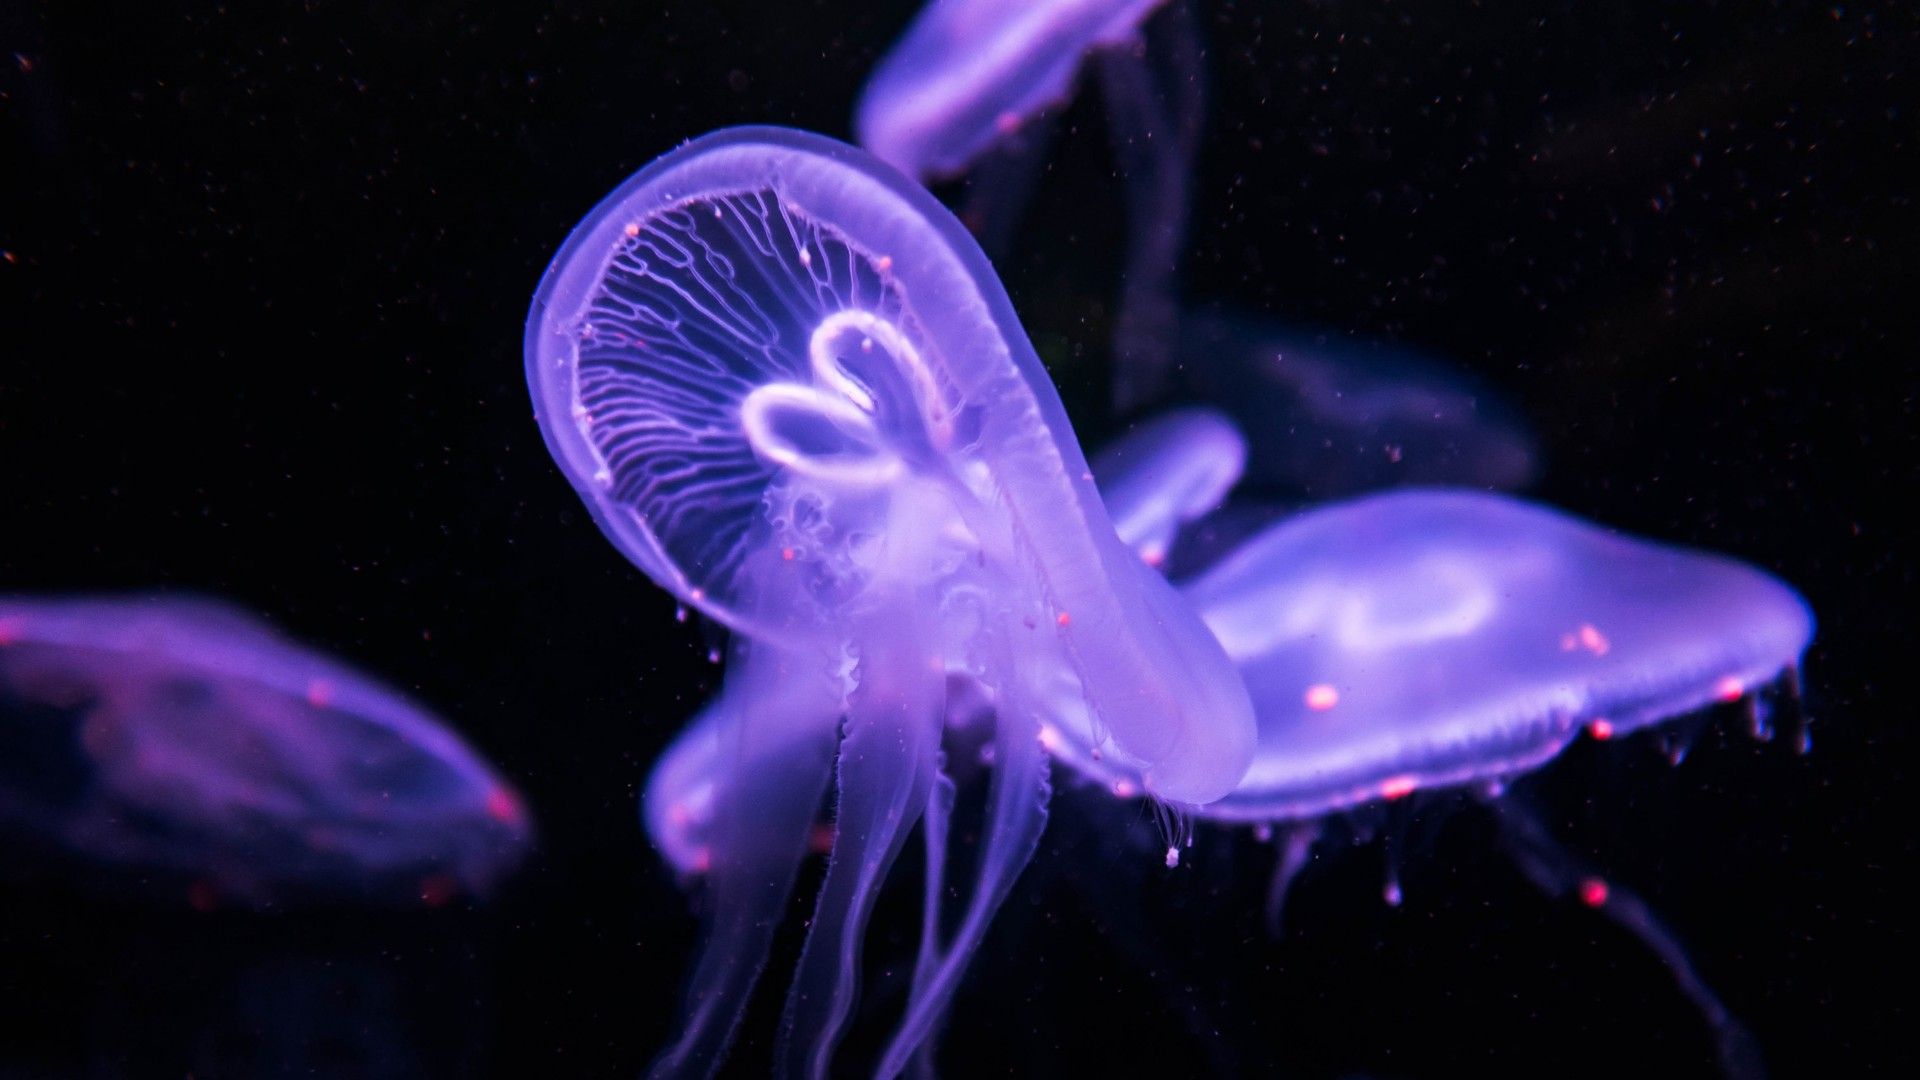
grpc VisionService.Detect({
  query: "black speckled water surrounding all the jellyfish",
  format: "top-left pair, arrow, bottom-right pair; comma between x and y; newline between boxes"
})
0,0 -> 1920,1076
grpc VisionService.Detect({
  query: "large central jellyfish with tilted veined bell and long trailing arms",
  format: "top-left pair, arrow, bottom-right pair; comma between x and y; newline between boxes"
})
526,129 -> 1254,1076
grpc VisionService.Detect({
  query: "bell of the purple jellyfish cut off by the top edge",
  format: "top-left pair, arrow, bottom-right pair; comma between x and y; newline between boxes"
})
854,0 -> 1165,179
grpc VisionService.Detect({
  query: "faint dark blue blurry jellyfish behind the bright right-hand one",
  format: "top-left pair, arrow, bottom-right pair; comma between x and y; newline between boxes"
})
1181,311 -> 1538,500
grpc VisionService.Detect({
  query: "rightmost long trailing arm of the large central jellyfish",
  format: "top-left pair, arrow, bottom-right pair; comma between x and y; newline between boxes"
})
876,634 -> 1052,1080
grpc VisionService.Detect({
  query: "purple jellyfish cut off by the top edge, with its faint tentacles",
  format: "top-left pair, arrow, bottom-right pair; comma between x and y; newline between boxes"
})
854,0 -> 1204,411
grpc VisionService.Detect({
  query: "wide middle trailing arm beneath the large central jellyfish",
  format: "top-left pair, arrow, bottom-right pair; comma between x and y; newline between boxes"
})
780,605 -> 947,1078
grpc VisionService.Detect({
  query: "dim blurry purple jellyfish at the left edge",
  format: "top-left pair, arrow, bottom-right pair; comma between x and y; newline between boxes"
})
0,596 -> 532,909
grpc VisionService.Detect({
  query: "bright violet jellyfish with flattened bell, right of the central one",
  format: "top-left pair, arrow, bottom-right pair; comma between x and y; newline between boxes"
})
1060,490 -> 1812,1074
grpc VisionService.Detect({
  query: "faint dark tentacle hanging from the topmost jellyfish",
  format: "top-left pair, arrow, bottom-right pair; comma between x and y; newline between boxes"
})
1098,0 -> 1206,413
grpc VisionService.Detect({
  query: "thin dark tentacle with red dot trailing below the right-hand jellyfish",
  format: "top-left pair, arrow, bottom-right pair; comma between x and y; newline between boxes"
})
1488,796 -> 1766,1080
